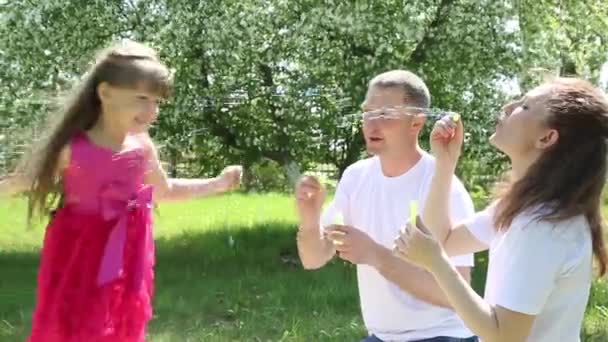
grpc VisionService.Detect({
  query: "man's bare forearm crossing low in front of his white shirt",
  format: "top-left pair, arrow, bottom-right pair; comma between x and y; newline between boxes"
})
374,245 -> 471,308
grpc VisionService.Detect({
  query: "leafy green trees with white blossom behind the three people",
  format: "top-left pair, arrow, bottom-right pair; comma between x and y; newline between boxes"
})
0,0 -> 608,192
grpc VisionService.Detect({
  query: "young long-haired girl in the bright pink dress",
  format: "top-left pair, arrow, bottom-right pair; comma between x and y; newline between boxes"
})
0,41 -> 241,342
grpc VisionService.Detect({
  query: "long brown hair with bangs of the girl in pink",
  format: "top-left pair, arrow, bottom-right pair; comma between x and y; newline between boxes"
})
16,41 -> 172,222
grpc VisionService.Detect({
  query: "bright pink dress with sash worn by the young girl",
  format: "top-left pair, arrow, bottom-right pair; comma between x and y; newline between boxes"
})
29,134 -> 154,342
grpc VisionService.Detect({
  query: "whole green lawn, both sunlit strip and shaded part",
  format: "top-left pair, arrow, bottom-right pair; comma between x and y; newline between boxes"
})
0,194 -> 608,342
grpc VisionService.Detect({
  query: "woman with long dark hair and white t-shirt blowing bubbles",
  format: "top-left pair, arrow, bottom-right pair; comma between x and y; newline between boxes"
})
396,78 -> 608,342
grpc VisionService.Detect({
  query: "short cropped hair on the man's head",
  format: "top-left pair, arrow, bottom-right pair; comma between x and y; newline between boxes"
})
369,70 -> 431,108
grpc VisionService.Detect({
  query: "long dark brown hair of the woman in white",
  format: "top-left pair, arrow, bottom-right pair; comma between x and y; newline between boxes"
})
494,78 -> 608,276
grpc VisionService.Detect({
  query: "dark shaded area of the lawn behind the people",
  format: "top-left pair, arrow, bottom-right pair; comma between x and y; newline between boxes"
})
0,223 -> 608,342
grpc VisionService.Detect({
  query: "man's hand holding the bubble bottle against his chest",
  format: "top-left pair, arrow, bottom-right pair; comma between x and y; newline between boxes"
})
326,225 -> 383,267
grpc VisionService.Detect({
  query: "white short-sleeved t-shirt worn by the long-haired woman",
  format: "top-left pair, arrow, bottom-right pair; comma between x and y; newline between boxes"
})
464,206 -> 593,342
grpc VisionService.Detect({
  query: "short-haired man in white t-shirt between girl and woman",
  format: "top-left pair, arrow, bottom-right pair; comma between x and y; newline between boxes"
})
296,70 -> 477,342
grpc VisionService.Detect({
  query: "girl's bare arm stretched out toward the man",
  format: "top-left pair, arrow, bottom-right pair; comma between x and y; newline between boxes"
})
140,135 -> 242,201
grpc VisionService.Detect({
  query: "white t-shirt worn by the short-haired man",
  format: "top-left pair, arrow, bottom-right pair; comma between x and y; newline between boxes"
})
321,153 -> 475,341
